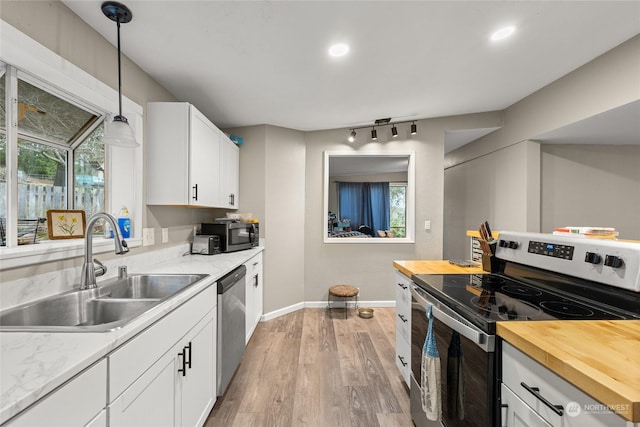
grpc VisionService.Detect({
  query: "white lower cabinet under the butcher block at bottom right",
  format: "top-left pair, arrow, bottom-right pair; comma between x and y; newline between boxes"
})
501,342 -> 633,427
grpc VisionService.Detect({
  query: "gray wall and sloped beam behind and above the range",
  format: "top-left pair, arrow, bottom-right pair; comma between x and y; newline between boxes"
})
443,36 -> 640,258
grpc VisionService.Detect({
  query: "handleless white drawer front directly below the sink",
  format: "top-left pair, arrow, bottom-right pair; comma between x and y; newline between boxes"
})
109,286 -> 218,402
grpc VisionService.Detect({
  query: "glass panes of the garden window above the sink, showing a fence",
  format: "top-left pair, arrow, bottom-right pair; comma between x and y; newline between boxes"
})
0,65 -> 105,246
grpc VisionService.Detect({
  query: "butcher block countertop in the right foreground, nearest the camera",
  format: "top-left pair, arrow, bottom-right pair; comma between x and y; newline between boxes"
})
500,322 -> 640,423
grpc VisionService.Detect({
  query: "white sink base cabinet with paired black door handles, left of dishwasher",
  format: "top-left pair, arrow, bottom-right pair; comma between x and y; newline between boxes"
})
108,286 -> 217,427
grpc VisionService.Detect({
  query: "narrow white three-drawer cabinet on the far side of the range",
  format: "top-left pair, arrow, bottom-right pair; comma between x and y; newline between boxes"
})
394,271 -> 412,387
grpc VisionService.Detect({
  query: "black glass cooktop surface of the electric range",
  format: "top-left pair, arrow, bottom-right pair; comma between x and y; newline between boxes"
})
413,274 -> 633,333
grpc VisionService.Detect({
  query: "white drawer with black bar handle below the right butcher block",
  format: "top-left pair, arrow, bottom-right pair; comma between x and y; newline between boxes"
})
502,342 -> 626,427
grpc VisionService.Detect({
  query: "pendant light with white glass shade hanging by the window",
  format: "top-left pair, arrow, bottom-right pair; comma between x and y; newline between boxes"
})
102,1 -> 140,148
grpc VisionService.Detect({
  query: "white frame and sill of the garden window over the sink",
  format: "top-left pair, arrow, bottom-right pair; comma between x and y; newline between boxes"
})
0,20 -> 144,270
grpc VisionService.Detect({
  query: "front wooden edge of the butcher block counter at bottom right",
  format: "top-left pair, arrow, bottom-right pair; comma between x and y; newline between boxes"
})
497,322 -> 640,423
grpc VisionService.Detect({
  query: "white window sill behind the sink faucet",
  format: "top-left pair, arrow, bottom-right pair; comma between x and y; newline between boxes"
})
0,237 -> 142,271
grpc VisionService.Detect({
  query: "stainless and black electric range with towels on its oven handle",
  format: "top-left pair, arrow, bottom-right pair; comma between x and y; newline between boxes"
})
411,232 -> 640,427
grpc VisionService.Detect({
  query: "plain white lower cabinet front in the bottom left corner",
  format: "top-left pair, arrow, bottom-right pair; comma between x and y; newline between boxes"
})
6,359 -> 107,427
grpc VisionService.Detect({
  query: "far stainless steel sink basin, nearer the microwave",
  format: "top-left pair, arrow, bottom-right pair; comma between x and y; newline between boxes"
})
101,274 -> 206,299
